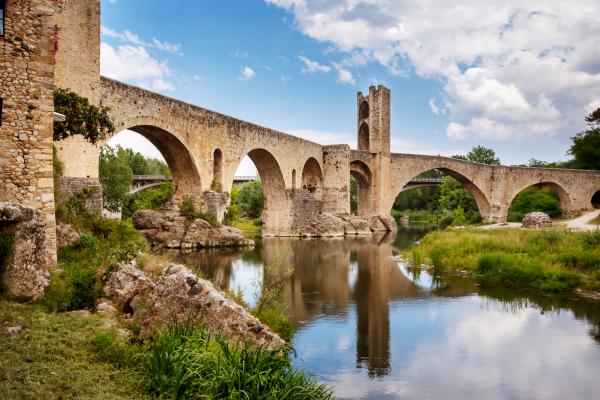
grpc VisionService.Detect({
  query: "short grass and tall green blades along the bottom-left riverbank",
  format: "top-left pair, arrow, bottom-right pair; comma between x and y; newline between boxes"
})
0,301 -> 331,400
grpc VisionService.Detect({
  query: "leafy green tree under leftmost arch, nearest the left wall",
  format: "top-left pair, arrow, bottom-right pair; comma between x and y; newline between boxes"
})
100,146 -> 133,212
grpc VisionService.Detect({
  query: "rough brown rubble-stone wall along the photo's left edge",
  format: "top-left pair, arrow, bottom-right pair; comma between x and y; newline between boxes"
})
0,0 -> 63,262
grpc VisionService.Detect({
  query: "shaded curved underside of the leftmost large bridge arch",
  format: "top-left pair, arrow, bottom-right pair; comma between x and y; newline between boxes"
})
129,125 -> 202,204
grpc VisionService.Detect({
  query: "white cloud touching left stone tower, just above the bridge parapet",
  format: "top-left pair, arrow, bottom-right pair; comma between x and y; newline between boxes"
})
100,43 -> 175,91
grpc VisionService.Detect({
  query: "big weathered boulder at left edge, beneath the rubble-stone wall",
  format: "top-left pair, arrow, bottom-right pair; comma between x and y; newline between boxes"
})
0,203 -> 50,299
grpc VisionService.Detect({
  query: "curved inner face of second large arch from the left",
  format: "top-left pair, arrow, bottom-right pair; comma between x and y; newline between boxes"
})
248,149 -> 289,236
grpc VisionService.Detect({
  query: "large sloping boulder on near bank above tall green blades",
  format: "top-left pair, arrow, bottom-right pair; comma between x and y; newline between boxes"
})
105,264 -> 285,348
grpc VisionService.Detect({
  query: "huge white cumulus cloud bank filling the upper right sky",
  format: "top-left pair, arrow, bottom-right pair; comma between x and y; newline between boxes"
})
265,0 -> 600,140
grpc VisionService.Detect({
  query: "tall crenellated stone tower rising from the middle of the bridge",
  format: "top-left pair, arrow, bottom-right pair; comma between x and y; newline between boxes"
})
357,85 -> 391,217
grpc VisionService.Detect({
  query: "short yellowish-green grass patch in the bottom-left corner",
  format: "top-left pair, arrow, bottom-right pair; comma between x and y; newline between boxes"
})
0,300 -> 151,400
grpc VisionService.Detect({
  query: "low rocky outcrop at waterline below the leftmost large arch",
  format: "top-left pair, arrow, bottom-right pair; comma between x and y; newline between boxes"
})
133,210 -> 254,249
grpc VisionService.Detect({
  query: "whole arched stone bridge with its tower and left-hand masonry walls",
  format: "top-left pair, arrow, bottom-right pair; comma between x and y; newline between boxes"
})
0,0 -> 600,268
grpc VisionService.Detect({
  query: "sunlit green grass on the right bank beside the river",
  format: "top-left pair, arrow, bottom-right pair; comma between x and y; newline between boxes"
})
405,229 -> 600,292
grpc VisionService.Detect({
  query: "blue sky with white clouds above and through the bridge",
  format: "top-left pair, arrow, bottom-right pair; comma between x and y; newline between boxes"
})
101,0 -> 600,175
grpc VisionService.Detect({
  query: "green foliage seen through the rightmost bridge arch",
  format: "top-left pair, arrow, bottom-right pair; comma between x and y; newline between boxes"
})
508,186 -> 562,222
